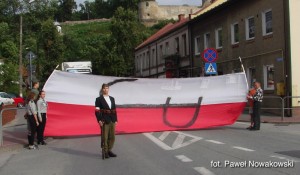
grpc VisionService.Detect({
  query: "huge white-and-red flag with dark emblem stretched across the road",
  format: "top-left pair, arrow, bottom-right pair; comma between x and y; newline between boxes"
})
44,70 -> 248,136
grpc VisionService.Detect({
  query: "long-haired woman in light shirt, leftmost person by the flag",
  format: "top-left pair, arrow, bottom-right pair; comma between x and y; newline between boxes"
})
26,92 -> 39,149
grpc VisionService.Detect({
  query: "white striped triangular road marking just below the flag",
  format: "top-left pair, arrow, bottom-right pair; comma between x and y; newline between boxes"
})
144,131 -> 202,150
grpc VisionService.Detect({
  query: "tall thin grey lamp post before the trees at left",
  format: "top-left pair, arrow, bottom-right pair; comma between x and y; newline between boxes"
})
19,0 -> 35,97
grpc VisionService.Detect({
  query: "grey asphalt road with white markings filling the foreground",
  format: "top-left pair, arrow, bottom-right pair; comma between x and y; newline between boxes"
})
0,118 -> 300,175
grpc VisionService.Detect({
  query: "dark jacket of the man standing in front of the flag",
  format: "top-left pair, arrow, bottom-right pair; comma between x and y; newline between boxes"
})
95,95 -> 118,123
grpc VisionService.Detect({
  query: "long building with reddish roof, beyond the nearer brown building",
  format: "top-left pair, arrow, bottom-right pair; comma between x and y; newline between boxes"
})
135,15 -> 190,78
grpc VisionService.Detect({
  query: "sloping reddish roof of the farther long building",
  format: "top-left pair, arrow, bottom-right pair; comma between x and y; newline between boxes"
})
135,18 -> 189,50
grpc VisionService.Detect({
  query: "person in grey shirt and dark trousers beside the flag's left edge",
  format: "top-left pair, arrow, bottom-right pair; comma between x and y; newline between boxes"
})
37,90 -> 48,145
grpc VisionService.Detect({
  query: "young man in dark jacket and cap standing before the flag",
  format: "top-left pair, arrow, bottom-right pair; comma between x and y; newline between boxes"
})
95,84 -> 118,159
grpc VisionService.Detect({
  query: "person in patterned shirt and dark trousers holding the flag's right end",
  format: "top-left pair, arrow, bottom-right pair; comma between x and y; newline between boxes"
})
248,82 -> 263,131
